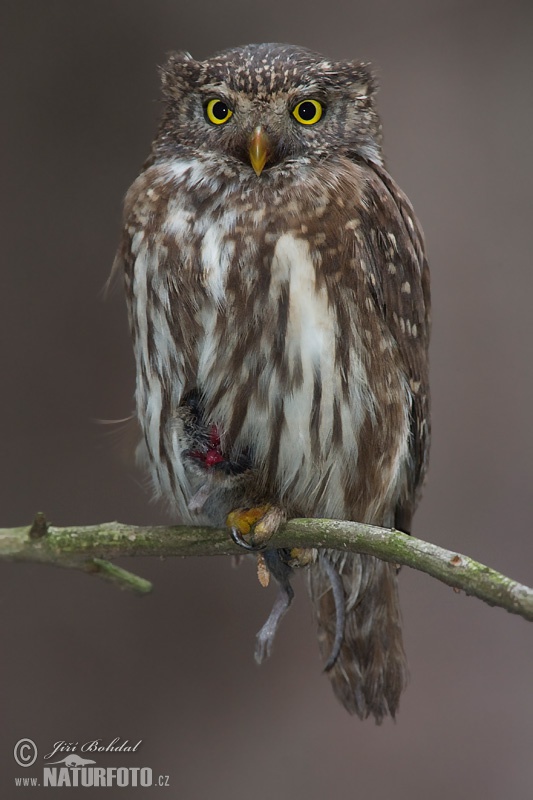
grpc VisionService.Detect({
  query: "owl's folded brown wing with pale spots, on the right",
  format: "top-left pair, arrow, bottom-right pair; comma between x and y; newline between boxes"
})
356,159 -> 431,532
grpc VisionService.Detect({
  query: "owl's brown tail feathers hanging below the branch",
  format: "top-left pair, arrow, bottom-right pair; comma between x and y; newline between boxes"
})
308,550 -> 407,723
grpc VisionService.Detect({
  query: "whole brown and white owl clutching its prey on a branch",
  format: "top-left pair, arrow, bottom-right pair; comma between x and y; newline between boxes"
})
115,44 -> 430,722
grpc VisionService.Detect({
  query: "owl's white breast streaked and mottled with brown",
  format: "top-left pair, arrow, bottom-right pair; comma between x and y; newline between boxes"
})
142,164 -> 409,522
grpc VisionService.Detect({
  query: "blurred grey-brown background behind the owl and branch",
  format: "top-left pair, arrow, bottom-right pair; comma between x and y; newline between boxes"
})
0,0 -> 533,800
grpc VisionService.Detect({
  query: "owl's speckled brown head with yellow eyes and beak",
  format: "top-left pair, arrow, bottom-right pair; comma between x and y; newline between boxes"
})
154,44 -> 381,176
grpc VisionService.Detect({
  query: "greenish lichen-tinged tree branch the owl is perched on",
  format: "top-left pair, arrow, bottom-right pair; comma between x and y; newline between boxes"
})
0,514 -> 533,621
